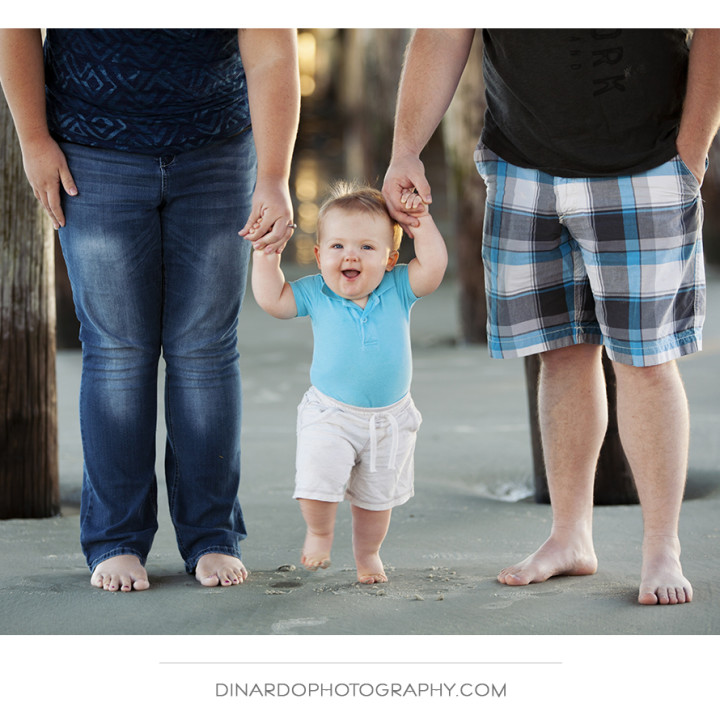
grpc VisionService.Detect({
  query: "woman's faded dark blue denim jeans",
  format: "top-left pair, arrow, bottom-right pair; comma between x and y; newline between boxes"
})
60,131 -> 257,572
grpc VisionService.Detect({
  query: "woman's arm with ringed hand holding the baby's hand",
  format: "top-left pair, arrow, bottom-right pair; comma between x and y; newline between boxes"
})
238,29 -> 300,252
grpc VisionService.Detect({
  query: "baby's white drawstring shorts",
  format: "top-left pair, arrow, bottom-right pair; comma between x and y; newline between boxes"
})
293,387 -> 422,510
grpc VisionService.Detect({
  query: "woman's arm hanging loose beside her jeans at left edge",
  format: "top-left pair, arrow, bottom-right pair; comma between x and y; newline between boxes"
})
0,29 -> 77,229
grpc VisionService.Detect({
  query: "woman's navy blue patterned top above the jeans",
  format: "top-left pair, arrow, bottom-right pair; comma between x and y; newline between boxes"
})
45,29 -> 250,155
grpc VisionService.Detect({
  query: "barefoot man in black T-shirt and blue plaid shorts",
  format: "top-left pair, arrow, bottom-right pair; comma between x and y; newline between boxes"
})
383,29 -> 720,605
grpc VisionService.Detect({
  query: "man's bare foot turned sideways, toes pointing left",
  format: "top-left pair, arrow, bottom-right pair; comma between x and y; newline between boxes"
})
498,536 -> 597,585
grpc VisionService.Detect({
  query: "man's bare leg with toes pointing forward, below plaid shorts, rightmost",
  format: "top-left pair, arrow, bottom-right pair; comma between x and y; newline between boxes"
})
615,361 -> 692,605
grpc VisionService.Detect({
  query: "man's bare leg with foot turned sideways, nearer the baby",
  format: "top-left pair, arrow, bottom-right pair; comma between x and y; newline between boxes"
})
498,344 -> 608,585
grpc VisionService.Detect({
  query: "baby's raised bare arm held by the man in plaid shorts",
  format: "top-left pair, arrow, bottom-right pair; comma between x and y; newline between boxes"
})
402,192 -> 448,297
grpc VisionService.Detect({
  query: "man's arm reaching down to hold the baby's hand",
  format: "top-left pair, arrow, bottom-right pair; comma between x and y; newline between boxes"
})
383,28 -> 475,228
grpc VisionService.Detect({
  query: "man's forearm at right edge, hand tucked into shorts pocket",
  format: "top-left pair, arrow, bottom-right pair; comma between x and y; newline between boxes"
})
677,29 -> 720,182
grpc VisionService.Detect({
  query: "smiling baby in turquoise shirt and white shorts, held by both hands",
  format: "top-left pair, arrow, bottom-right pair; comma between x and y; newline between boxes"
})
252,185 -> 447,584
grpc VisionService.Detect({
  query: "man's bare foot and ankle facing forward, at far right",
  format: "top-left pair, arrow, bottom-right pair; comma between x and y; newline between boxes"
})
638,536 -> 692,605
